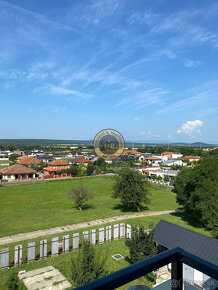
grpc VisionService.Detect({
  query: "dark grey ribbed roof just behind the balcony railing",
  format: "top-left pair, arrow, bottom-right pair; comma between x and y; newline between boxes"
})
154,220 -> 218,266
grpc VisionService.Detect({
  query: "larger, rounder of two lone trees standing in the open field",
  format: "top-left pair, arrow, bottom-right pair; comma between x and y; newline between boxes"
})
113,168 -> 150,211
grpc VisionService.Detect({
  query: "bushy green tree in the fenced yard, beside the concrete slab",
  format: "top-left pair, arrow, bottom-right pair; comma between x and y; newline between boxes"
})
72,240 -> 106,286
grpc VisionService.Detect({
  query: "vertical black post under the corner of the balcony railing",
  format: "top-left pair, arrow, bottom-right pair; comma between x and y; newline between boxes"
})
171,261 -> 183,290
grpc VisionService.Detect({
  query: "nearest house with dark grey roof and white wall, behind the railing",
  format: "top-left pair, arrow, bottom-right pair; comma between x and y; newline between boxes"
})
154,220 -> 218,290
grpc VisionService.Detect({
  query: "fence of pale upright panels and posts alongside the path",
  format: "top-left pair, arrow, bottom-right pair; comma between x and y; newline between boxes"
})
0,223 -> 132,269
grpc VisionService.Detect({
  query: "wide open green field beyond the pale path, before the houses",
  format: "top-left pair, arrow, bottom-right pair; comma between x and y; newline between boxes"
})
0,177 -> 178,237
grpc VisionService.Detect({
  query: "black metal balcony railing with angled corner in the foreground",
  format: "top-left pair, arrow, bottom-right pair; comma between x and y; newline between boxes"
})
76,248 -> 218,290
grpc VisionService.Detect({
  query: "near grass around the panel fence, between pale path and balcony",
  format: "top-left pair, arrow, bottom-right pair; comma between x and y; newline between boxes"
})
0,213 -> 210,289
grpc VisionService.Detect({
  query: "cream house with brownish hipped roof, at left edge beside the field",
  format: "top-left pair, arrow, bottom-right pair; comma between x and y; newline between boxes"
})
0,164 -> 36,181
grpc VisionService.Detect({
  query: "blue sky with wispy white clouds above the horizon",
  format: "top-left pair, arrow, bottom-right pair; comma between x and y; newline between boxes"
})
0,0 -> 218,142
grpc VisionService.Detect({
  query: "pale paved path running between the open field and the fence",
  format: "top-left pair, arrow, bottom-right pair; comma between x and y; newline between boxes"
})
0,210 -> 182,246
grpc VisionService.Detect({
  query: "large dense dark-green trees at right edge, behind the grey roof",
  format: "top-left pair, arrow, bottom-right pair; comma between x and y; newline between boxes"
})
174,157 -> 218,238
